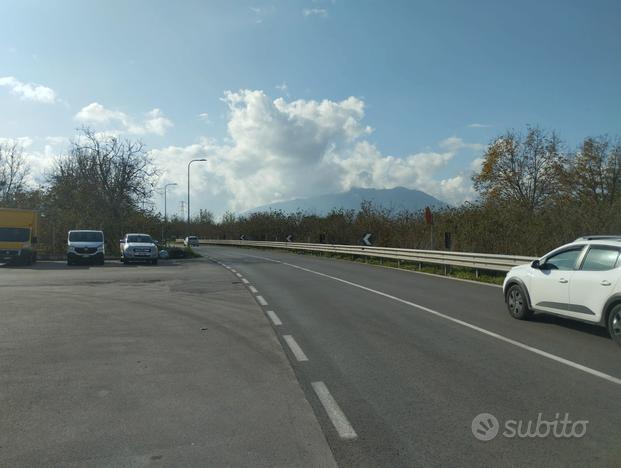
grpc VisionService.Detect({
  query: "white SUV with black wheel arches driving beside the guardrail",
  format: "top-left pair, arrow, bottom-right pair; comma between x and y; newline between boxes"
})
503,236 -> 621,345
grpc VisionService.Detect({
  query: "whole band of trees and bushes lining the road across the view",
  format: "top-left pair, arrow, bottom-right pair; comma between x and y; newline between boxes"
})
0,127 -> 621,258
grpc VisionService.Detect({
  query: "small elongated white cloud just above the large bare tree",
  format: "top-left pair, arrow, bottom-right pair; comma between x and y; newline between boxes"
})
75,102 -> 173,136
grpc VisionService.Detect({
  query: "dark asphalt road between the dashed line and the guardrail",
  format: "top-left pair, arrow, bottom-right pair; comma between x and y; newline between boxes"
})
199,246 -> 621,467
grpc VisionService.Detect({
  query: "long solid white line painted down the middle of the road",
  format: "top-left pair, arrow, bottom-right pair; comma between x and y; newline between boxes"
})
240,252 -> 621,385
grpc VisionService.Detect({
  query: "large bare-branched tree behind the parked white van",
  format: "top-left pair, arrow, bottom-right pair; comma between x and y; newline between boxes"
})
48,128 -> 158,252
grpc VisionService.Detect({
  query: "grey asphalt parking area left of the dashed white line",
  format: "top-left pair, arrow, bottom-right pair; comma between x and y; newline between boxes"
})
0,259 -> 336,468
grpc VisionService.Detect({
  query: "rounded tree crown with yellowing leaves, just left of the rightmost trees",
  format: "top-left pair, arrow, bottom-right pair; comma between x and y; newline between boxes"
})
473,127 -> 564,212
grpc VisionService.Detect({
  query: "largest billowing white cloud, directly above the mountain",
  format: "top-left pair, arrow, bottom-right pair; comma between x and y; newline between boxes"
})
152,90 -> 484,212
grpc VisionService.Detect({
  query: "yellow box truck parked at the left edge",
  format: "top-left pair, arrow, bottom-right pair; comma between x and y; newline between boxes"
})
0,208 -> 39,265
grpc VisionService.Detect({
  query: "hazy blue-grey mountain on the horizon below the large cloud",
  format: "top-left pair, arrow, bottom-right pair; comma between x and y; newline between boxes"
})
245,187 -> 448,216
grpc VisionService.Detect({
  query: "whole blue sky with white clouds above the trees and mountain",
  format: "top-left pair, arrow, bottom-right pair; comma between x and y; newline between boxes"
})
0,0 -> 621,213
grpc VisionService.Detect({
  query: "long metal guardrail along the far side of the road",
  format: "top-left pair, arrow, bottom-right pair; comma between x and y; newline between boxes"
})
190,239 -> 535,272
